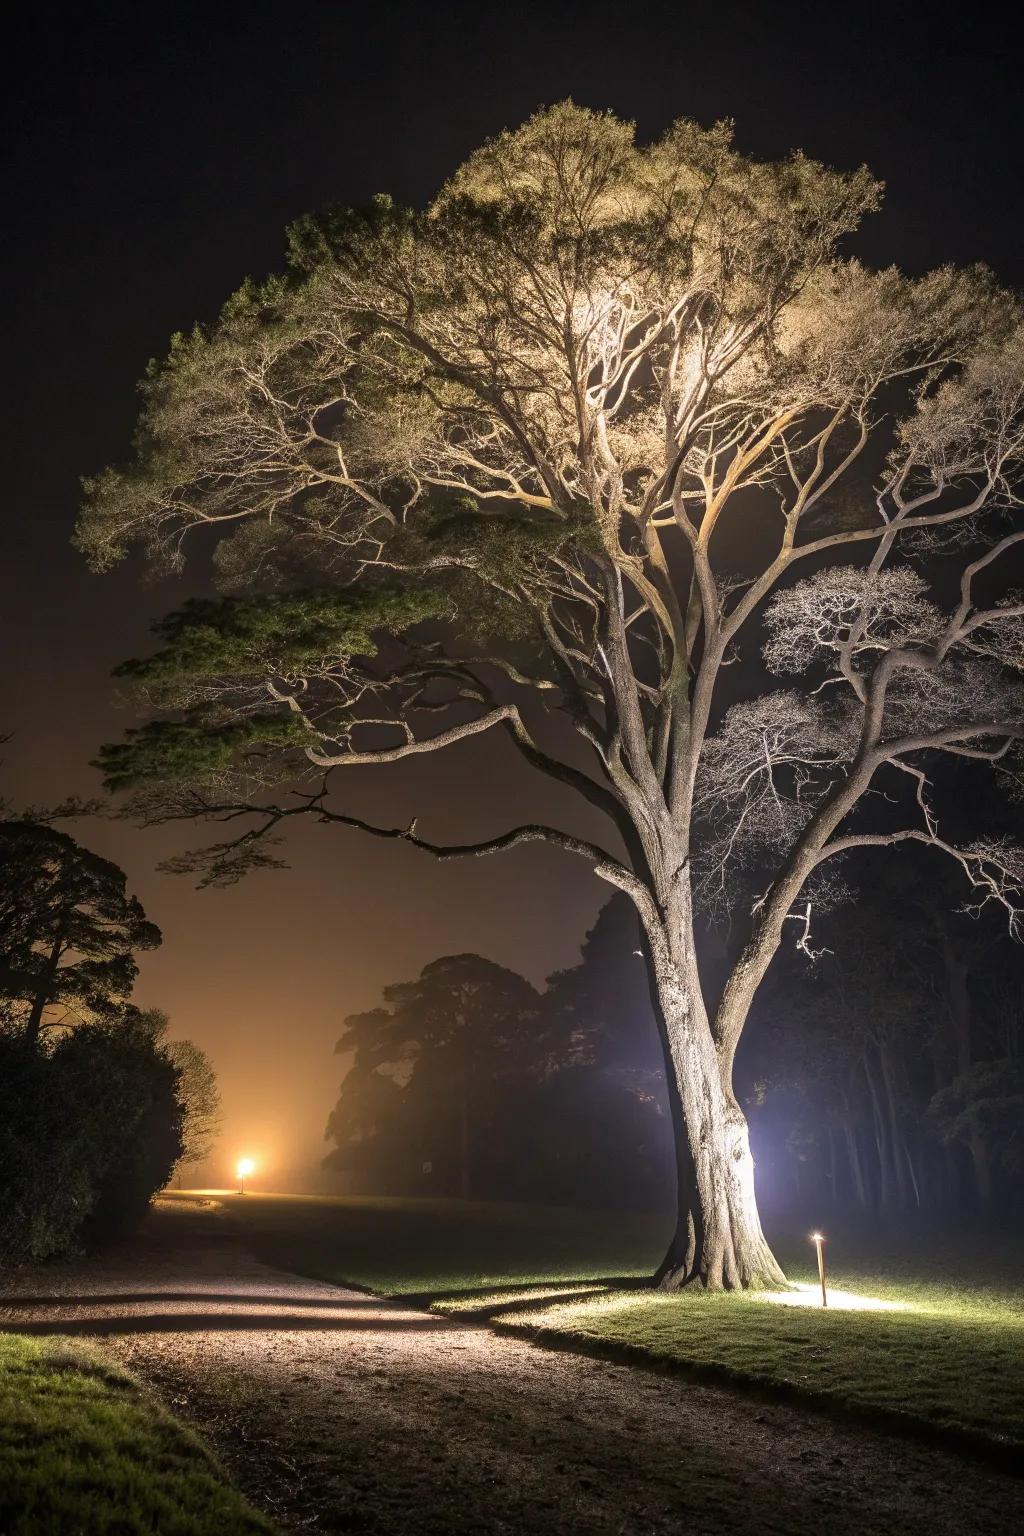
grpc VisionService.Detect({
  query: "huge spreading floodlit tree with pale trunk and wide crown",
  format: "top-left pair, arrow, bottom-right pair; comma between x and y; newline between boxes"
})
78,103 -> 1024,1287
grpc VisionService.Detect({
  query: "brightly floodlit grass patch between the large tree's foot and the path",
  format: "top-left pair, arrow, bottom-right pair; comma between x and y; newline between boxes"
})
475,1233 -> 1024,1458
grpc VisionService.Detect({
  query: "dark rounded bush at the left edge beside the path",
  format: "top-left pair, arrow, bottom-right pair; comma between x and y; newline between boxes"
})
0,1011 -> 181,1261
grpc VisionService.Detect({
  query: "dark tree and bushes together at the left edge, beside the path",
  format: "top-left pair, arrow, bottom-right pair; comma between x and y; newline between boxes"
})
0,819 -> 218,1261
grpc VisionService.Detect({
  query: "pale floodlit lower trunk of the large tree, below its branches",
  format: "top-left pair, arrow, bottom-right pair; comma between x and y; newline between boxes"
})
654,966 -> 786,1290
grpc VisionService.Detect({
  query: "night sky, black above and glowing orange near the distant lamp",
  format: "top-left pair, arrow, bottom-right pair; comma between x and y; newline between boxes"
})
0,0 -> 1024,1183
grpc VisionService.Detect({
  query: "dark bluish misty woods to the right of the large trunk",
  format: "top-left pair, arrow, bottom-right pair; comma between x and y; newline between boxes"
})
746,852 -> 1024,1217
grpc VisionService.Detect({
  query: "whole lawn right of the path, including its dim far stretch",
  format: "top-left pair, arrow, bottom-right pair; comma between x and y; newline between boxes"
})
204,1195 -> 1024,1458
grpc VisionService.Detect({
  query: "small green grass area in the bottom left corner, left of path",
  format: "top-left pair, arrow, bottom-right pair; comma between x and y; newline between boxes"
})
0,1333 -> 273,1536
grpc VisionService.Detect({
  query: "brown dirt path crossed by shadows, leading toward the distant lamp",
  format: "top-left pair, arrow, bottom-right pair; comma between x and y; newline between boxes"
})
0,1203 -> 1024,1536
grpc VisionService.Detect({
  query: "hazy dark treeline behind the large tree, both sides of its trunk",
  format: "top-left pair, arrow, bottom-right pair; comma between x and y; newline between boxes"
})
333,852 -> 1024,1218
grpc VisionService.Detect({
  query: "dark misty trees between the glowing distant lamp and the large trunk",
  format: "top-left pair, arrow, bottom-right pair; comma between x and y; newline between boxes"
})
325,899 -> 674,1207
